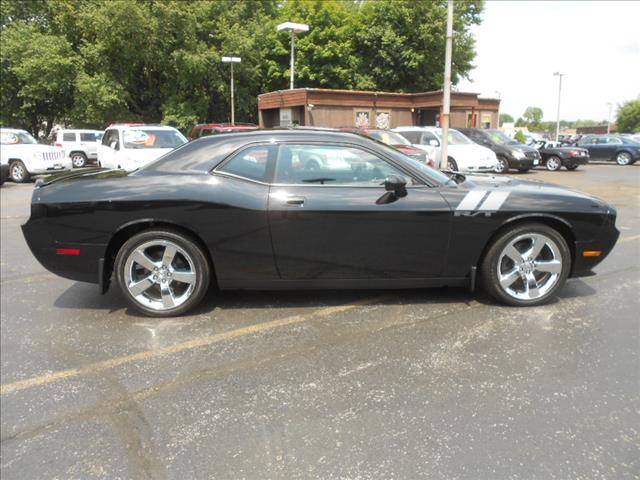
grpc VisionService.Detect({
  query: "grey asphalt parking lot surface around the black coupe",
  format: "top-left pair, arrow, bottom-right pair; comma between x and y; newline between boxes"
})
0,164 -> 640,480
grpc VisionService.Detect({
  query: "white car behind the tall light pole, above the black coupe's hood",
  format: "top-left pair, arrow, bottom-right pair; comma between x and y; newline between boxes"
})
392,127 -> 498,172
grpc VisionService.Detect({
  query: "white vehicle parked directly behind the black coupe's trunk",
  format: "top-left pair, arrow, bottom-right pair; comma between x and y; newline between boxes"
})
98,123 -> 187,172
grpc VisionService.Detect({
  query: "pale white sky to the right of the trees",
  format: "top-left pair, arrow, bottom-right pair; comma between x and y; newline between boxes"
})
454,0 -> 640,121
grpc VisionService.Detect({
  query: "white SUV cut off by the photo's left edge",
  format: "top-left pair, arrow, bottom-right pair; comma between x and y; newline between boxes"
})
0,128 -> 71,183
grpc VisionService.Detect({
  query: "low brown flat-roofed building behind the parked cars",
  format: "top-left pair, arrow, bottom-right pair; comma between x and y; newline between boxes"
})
258,88 -> 500,128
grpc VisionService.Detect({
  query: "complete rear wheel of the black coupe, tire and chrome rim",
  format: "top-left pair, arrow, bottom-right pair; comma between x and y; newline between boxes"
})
115,229 -> 210,317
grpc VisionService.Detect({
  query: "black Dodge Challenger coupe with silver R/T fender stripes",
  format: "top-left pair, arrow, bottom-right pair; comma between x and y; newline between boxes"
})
22,129 -> 619,316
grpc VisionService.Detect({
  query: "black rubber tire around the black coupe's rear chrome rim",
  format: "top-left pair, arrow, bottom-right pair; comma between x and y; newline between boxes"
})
114,229 -> 211,317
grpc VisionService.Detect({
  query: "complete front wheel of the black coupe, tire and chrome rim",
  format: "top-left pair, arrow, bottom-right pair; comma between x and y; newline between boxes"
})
481,223 -> 571,306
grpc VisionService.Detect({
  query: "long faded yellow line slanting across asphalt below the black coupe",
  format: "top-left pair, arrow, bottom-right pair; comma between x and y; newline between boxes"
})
0,297 -> 383,395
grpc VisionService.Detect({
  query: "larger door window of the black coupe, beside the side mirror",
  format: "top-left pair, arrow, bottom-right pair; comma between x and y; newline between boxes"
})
274,144 -> 412,186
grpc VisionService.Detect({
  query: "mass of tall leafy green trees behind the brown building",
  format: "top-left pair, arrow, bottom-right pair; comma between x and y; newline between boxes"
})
0,0 -> 483,133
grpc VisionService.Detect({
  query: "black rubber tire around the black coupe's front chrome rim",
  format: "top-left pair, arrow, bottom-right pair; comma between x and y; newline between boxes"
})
480,223 -> 571,307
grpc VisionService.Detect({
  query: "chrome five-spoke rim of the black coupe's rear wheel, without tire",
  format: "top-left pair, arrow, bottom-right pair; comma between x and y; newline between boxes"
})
124,240 -> 196,311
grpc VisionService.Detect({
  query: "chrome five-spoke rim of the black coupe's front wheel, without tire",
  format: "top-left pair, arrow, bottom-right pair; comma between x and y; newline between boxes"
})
498,233 -> 562,300
